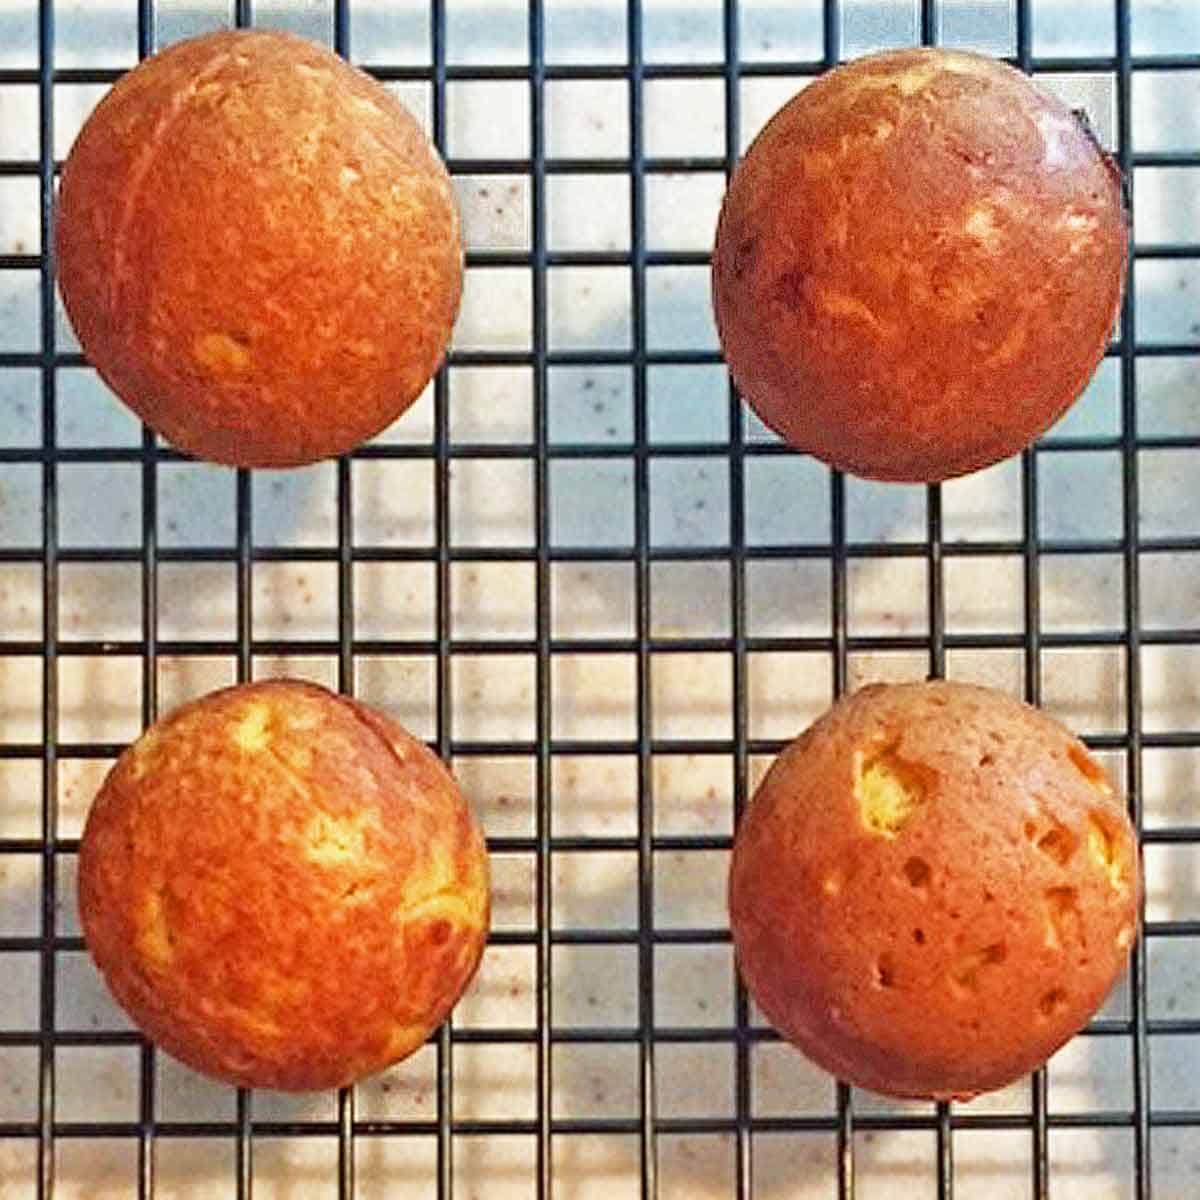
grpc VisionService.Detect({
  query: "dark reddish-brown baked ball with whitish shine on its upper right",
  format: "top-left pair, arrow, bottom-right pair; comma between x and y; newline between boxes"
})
713,49 -> 1127,481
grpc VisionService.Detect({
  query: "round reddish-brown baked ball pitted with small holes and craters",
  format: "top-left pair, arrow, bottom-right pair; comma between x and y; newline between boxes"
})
730,683 -> 1140,1099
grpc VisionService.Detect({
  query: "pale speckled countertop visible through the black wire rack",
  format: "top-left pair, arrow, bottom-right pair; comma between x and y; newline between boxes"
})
0,0 -> 1200,1200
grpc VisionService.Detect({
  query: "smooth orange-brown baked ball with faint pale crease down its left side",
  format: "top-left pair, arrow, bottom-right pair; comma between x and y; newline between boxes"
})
58,31 -> 462,467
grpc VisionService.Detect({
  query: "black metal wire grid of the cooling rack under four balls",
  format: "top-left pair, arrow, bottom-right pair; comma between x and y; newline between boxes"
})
0,0 -> 1200,1200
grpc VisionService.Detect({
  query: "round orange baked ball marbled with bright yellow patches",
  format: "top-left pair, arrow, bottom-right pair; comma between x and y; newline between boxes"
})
79,680 -> 488,1091
